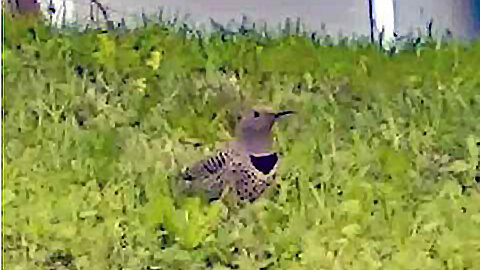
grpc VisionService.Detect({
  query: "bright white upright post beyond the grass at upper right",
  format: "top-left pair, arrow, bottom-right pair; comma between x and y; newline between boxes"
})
369,0 -> 395,49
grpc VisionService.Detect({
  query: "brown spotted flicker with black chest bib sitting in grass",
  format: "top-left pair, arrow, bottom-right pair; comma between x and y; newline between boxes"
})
181,109 -> 293,202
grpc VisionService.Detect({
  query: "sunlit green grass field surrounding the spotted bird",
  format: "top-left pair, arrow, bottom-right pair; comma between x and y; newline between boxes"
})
2,14 -> 480,270
